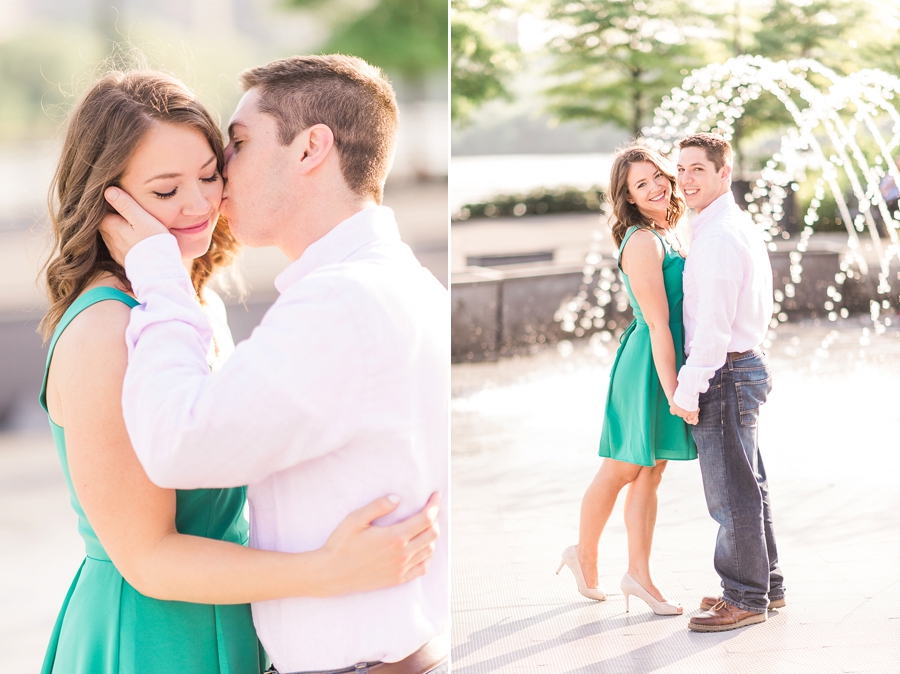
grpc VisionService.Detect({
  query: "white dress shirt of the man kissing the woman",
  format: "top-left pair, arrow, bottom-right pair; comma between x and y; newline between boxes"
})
123,207 -> 450,672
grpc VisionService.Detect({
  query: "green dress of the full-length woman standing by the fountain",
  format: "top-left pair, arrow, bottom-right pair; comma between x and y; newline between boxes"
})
599,227 -> 697,466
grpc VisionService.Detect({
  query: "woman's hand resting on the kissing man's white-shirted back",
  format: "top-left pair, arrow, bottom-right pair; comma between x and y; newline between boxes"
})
316,492 -> 441,597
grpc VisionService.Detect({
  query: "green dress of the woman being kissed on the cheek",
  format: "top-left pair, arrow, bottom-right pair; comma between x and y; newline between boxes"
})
41,288 -> 266,674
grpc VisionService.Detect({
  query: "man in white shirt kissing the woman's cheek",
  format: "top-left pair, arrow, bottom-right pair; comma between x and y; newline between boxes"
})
103,55 -> 450,674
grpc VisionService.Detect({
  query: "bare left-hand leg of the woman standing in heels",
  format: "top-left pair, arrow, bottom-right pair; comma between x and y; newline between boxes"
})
578,459 -> 642,588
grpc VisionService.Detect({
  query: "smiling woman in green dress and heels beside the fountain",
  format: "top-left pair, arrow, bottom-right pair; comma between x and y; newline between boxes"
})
557,146 -> 697,615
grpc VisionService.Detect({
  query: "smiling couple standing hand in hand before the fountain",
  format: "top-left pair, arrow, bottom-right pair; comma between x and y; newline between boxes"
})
557,133 -> 785,632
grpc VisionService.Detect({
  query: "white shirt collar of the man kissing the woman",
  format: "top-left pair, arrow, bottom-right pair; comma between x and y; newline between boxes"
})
275,206 -> 400,293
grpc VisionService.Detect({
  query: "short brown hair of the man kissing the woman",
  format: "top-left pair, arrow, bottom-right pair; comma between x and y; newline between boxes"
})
241,54 -> 397,204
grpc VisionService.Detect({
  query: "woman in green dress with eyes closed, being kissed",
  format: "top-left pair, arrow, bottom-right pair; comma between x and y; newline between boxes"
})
41,71 -> 437,674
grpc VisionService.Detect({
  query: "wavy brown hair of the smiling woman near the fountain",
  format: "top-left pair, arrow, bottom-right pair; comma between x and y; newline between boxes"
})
606,145 -> 687,246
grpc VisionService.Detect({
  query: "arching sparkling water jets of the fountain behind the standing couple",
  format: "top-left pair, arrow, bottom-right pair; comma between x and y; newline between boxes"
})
555,56 -> 900,348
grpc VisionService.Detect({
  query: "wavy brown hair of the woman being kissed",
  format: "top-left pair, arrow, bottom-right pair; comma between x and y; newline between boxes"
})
40,70 -> 238,341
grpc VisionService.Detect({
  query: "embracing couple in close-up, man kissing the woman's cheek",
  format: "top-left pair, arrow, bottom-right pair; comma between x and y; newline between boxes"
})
41,55 -> 450,674
